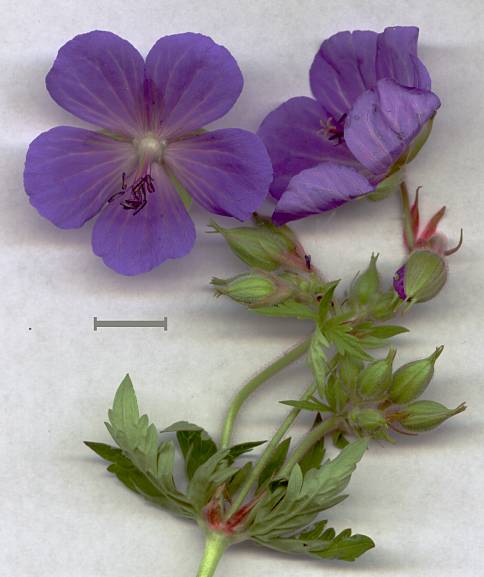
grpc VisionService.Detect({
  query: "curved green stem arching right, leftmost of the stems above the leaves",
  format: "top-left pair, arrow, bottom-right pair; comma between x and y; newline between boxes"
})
221,338 -> 311,449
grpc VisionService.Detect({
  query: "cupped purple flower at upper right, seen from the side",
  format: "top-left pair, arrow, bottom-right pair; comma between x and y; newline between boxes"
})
259,27 -> 440,224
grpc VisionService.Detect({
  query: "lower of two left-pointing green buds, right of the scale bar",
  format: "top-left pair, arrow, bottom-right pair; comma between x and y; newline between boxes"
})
212,272 -> 292,308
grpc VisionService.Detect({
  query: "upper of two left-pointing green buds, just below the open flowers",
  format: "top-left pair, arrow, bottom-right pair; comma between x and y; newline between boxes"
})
211,222 -> 308,271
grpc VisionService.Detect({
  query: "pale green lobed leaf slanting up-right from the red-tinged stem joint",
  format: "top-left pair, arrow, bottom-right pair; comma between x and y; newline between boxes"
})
250,439 -> 368,540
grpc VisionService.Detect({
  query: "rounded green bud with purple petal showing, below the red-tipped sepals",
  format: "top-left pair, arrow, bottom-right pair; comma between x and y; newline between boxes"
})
393,250 -> 447,303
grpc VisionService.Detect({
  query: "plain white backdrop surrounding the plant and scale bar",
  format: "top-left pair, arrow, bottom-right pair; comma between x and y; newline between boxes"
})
0,0 -> 484,577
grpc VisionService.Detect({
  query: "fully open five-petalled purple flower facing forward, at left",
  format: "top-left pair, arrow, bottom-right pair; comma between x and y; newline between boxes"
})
24,31 -> 272,275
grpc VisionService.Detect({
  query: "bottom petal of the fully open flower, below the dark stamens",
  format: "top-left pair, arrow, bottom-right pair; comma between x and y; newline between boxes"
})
92,164 -> 195,275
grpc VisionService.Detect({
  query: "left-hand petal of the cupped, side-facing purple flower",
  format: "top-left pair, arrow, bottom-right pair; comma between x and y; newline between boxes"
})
258,96 -> 357,199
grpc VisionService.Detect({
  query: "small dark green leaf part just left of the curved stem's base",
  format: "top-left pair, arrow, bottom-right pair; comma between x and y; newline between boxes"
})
162,421 -> 217,480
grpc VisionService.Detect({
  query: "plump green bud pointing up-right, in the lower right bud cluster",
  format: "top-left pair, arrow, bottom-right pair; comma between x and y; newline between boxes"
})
390,347 -> 444,404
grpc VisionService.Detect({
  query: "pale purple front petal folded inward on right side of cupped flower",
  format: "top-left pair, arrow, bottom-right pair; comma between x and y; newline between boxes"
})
345,79 -> 440,175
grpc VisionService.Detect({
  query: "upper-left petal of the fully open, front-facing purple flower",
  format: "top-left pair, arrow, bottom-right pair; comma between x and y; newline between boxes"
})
46,30 -> 145,136
